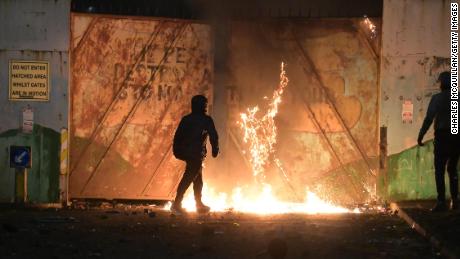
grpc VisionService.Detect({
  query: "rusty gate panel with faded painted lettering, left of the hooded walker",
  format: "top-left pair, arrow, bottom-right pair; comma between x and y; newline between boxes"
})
69,14 -> 213,199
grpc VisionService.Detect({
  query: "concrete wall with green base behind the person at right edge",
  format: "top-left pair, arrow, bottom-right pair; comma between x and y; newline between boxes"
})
380,0 -> 451,200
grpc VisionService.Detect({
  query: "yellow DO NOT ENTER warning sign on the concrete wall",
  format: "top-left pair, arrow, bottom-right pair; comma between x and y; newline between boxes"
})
9,60 -> 50,101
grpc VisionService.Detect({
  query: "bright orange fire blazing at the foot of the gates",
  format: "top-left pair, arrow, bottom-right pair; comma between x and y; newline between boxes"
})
166,63 -> 359,215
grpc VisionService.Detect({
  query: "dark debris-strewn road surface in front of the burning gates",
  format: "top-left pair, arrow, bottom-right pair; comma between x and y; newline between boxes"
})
0,207 -> 439,259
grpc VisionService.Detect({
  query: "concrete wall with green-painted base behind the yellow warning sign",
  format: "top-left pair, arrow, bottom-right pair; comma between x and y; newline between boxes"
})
0,0 -> 70,202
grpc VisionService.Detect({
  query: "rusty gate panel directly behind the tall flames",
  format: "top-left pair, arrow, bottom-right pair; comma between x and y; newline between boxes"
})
229,19 -> 379,203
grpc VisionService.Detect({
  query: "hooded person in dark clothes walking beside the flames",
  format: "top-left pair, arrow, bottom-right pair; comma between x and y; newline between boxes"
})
171,95 -> 219,215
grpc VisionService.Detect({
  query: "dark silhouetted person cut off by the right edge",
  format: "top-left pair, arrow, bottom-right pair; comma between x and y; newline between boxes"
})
417,72 -> 460,212
